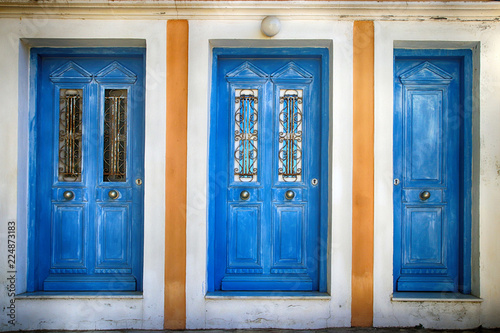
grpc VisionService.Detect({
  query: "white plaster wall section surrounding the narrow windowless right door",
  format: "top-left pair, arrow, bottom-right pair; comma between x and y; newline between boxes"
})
374,22 -> 500,329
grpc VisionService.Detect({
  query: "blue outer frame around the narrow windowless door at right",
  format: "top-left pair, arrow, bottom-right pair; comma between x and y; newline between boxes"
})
392,48 -> 474,294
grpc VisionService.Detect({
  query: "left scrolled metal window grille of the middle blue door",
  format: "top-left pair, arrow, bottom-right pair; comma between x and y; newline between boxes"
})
234,89 -> 258,182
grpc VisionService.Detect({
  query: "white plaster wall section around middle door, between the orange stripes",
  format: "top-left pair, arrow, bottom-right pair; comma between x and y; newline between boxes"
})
186,18 -> 352,329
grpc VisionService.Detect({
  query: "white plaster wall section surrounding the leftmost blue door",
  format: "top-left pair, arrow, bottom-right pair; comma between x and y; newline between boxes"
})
0,17 -> 166,330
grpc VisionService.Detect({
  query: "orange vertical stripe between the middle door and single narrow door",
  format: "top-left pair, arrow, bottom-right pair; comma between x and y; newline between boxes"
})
351,21 -> 374,327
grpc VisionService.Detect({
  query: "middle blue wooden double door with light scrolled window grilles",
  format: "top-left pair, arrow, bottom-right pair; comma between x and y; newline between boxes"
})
212,50 -> 328,291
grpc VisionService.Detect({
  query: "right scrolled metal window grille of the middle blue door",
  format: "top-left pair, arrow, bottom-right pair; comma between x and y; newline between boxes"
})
278,89 -> 302,182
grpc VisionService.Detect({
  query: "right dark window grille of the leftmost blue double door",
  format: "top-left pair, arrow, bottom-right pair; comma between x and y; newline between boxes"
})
103,89 -> 127,182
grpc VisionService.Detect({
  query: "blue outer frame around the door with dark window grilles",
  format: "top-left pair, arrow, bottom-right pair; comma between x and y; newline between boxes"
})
26,47 -> 146,292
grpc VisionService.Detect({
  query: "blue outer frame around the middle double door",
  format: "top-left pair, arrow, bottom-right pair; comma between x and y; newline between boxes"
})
207,47 -> 331,293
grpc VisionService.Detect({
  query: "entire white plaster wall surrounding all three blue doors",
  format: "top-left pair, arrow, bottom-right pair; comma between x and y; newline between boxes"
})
0,2 -> 500,330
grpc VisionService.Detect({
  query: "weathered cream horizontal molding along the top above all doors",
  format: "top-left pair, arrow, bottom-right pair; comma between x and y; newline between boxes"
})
0,0 -> 500,21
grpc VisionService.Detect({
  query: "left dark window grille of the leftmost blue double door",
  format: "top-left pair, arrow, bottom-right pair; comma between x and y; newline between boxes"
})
58,89 -> 82,182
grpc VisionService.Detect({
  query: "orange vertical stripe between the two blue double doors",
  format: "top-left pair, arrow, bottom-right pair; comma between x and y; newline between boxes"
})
163,20 -> 189,329
